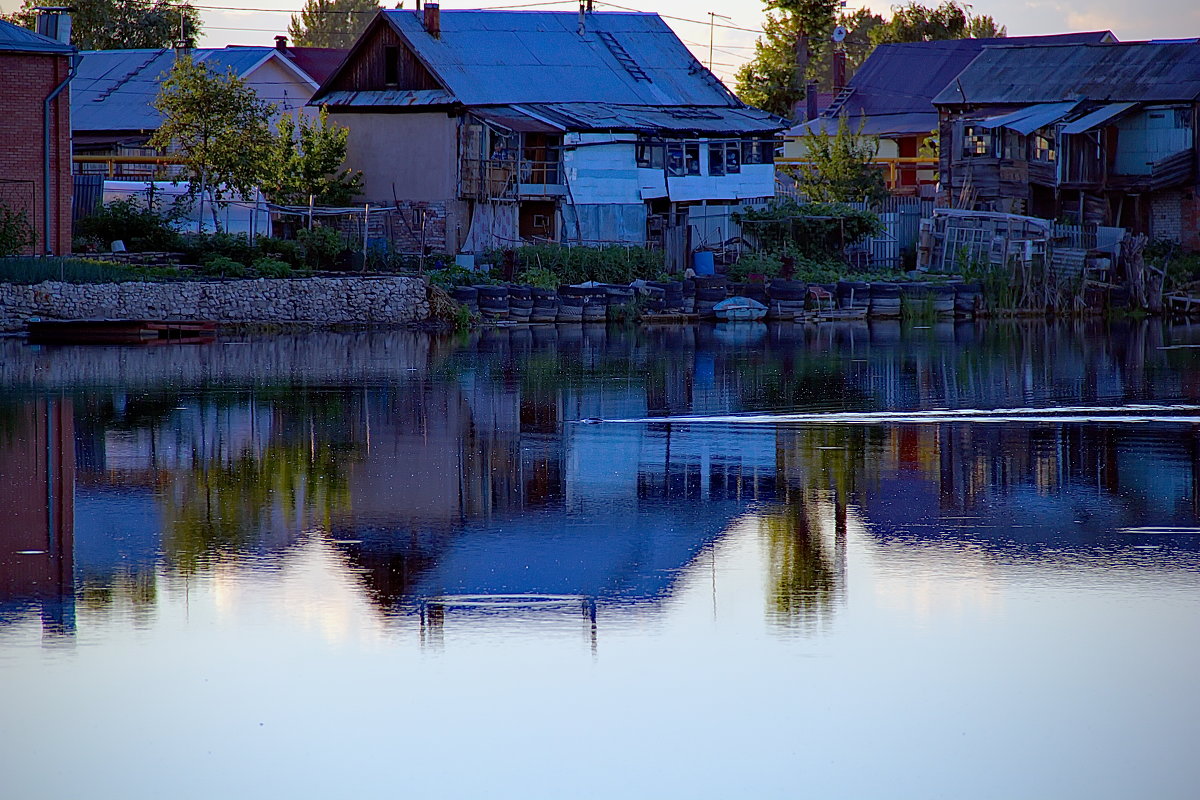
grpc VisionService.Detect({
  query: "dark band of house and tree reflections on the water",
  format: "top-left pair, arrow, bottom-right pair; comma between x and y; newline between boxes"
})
0,323 -> 1200,640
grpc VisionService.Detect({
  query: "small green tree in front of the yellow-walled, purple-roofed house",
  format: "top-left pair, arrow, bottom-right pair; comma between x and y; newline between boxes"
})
796,114 -> 888,203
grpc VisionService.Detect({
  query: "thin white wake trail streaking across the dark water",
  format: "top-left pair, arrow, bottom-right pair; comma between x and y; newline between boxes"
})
581,403 -> 1200,425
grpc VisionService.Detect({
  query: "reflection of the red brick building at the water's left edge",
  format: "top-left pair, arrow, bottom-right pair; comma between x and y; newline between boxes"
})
0,399 -> 76,637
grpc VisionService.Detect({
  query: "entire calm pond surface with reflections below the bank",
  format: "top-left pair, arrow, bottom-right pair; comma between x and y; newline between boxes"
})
0,323 -> 1200,800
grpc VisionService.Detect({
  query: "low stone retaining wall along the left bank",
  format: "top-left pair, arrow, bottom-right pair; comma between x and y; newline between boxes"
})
0,276 -> 430,330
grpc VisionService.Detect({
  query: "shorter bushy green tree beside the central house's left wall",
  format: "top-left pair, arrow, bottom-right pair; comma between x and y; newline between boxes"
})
262,108 -> 362,205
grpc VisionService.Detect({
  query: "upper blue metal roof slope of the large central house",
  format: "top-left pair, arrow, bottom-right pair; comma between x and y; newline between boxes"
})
383,11 -> 740,107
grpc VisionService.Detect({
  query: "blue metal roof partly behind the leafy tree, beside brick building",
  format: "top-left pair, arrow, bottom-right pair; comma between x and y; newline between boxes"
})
71,47 -> 316,131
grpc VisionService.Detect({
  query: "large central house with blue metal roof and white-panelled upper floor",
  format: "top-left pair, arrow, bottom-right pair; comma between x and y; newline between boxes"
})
304,4 -> 785,252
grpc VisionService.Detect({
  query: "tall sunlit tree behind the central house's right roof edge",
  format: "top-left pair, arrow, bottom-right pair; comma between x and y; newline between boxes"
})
736,0 -> 883,116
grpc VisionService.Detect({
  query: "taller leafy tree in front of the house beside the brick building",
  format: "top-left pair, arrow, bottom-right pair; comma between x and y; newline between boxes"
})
150,55 -> 275,230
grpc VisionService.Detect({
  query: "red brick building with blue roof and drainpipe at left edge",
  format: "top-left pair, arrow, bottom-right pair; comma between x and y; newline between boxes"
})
0,20 -> 74,254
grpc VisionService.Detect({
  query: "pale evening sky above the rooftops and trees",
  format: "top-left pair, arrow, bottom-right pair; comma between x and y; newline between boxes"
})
0,0 -> 1200,84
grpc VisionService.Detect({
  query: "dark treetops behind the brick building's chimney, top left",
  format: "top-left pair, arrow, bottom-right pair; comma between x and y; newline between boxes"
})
6,0 -> 200,50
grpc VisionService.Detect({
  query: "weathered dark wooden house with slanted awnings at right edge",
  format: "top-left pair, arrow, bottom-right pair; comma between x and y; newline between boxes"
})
934,41 -> 1200,248
